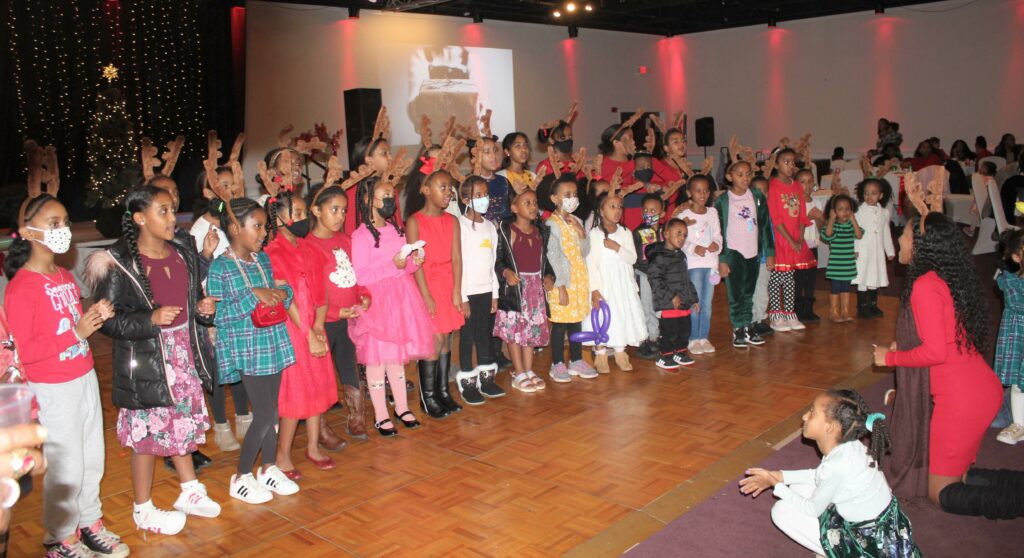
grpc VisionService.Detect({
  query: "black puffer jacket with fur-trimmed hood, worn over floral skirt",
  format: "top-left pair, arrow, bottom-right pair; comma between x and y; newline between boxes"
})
86,230 -> 215,409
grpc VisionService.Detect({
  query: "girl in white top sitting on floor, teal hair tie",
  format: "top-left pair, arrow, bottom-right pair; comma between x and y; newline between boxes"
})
739,389 -> 921,558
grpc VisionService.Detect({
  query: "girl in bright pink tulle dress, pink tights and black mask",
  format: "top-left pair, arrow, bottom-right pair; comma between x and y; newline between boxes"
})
348,177 -> 437,437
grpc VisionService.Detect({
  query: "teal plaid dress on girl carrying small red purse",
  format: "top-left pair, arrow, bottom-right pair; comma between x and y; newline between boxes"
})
206,252 -> 295,384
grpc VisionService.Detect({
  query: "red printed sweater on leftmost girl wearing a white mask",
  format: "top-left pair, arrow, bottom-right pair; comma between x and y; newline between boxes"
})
4,267 -> 93,384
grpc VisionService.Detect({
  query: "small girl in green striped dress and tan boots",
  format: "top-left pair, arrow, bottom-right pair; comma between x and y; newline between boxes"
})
821,194 -> 863,324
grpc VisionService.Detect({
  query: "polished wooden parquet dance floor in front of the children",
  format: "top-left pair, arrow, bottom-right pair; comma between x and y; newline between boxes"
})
9,281 -> 896,558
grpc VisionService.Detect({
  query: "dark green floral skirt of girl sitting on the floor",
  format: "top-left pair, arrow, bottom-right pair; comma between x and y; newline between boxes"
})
818,497 -> 921,558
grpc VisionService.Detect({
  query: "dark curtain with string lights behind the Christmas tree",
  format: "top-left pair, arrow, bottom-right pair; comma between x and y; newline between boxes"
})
0,0 -> 245,226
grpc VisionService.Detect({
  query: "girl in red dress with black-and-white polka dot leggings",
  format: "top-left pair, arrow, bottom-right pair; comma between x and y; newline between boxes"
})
768,147 -> 817,332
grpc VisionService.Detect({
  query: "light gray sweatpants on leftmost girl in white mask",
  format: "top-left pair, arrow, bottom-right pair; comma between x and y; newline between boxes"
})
29,371 -> 105,545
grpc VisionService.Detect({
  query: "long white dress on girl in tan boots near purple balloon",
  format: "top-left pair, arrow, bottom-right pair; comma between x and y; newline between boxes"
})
583,225 -> 647,348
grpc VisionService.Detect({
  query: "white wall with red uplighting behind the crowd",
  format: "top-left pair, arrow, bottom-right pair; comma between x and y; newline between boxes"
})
246,0 -> 1024,174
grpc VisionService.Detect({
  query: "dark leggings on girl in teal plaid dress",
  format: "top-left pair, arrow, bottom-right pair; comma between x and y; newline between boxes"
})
238,373 -> 281,475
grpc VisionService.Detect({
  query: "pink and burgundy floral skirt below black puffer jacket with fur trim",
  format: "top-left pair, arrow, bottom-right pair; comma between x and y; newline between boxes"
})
117,324 -> 210,457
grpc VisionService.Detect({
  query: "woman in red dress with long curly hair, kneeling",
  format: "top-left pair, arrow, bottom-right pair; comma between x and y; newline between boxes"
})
874,213 -> 1024,517
